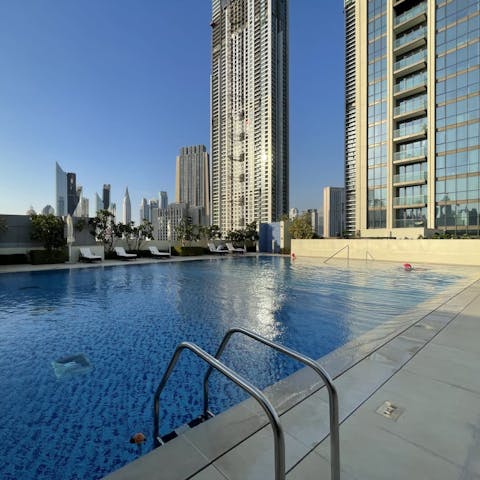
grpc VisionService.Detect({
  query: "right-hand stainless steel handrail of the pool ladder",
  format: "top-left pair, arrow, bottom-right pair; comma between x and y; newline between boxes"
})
203,327 -> 340,480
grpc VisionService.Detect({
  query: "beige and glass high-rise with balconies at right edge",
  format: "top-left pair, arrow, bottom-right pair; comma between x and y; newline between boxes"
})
345,0 -> 480,238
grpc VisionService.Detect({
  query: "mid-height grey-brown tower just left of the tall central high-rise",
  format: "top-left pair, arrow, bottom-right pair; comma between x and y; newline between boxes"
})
175,145 -> 210,224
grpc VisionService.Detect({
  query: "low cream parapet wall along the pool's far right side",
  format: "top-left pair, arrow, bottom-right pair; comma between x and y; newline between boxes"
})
291,238 -> 480,266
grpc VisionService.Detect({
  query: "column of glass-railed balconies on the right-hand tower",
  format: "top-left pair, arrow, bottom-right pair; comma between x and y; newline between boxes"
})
392,1 -> 428,228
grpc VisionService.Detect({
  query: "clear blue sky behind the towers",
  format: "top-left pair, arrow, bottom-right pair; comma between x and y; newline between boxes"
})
0,0 -> 344,218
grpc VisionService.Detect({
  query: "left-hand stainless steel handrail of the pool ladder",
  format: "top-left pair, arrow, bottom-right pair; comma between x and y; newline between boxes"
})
153,342 -> 285,480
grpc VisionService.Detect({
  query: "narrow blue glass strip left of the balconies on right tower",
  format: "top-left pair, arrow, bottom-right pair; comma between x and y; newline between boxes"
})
367,0 -> 387,228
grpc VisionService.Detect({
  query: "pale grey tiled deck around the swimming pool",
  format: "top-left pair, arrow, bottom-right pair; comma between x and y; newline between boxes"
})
0,257 -> 480,480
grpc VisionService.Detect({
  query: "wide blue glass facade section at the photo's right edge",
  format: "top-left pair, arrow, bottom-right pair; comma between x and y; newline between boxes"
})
435,0 -> 480,233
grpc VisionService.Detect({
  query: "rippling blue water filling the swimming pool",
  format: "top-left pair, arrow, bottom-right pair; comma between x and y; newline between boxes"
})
0,257 -> 459,480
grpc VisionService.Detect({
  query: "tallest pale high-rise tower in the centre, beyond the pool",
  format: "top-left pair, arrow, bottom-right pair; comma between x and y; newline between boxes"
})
211,0 -> 289,232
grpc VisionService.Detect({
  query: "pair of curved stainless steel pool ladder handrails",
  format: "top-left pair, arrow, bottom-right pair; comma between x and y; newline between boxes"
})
153,328 -> 340,480
